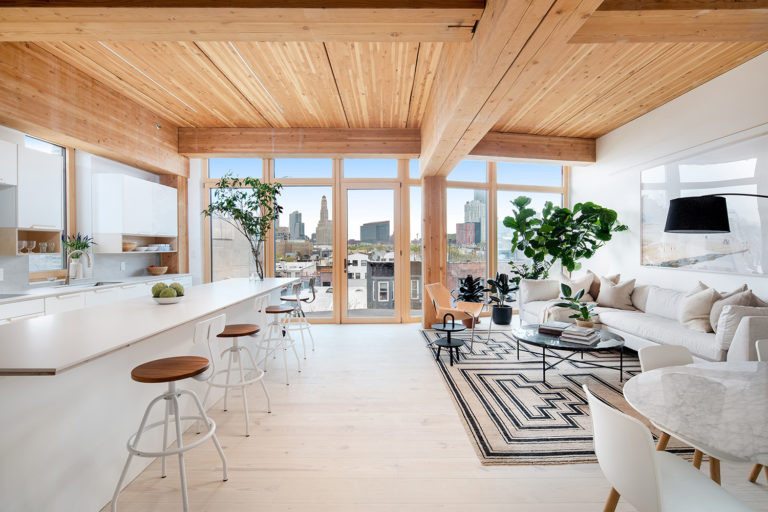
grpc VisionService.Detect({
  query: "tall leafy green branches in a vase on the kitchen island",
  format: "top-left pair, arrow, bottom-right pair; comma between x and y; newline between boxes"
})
202,173 -> 283,279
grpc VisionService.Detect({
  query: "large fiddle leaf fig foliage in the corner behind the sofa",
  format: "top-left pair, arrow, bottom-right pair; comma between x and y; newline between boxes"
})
504,196 -> 629,284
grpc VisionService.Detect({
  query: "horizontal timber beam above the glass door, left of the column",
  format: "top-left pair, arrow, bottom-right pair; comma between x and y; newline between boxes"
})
179,127 -> 421,158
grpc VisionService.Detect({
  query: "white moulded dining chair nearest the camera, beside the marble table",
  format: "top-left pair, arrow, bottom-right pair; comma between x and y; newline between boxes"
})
583,385 -> 752,512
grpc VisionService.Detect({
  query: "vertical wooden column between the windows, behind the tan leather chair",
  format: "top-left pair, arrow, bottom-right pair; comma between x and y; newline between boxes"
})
421,176 -> 448,327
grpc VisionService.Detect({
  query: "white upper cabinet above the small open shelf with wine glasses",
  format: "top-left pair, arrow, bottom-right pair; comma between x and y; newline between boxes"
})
17,147 -> 64,231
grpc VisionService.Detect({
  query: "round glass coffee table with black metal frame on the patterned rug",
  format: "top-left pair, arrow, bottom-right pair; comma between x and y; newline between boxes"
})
512,324 -> 624,382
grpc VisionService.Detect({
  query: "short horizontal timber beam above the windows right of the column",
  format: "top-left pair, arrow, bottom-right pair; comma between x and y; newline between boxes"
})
469,132 -> 596,163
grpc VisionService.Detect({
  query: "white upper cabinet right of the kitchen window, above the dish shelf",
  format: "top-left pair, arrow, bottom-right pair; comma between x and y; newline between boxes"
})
91,173 -> 178,237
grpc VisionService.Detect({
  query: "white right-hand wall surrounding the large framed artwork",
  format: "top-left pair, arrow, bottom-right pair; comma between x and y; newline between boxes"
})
570,53 -> 768,297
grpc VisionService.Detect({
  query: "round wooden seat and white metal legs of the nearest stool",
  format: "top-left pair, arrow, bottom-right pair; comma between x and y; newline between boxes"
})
112,356 -> 227,512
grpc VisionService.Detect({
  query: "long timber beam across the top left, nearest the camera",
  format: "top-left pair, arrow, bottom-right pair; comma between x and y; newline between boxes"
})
0,0 -> 484,41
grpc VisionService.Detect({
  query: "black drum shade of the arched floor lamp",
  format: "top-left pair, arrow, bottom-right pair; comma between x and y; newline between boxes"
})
664,196 -> 731,233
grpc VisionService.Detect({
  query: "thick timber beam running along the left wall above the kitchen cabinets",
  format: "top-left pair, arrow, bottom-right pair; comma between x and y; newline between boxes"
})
0,43 -> 189,176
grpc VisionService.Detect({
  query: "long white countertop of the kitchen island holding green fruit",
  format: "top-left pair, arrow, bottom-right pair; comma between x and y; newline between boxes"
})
0,278 -> 296,375
